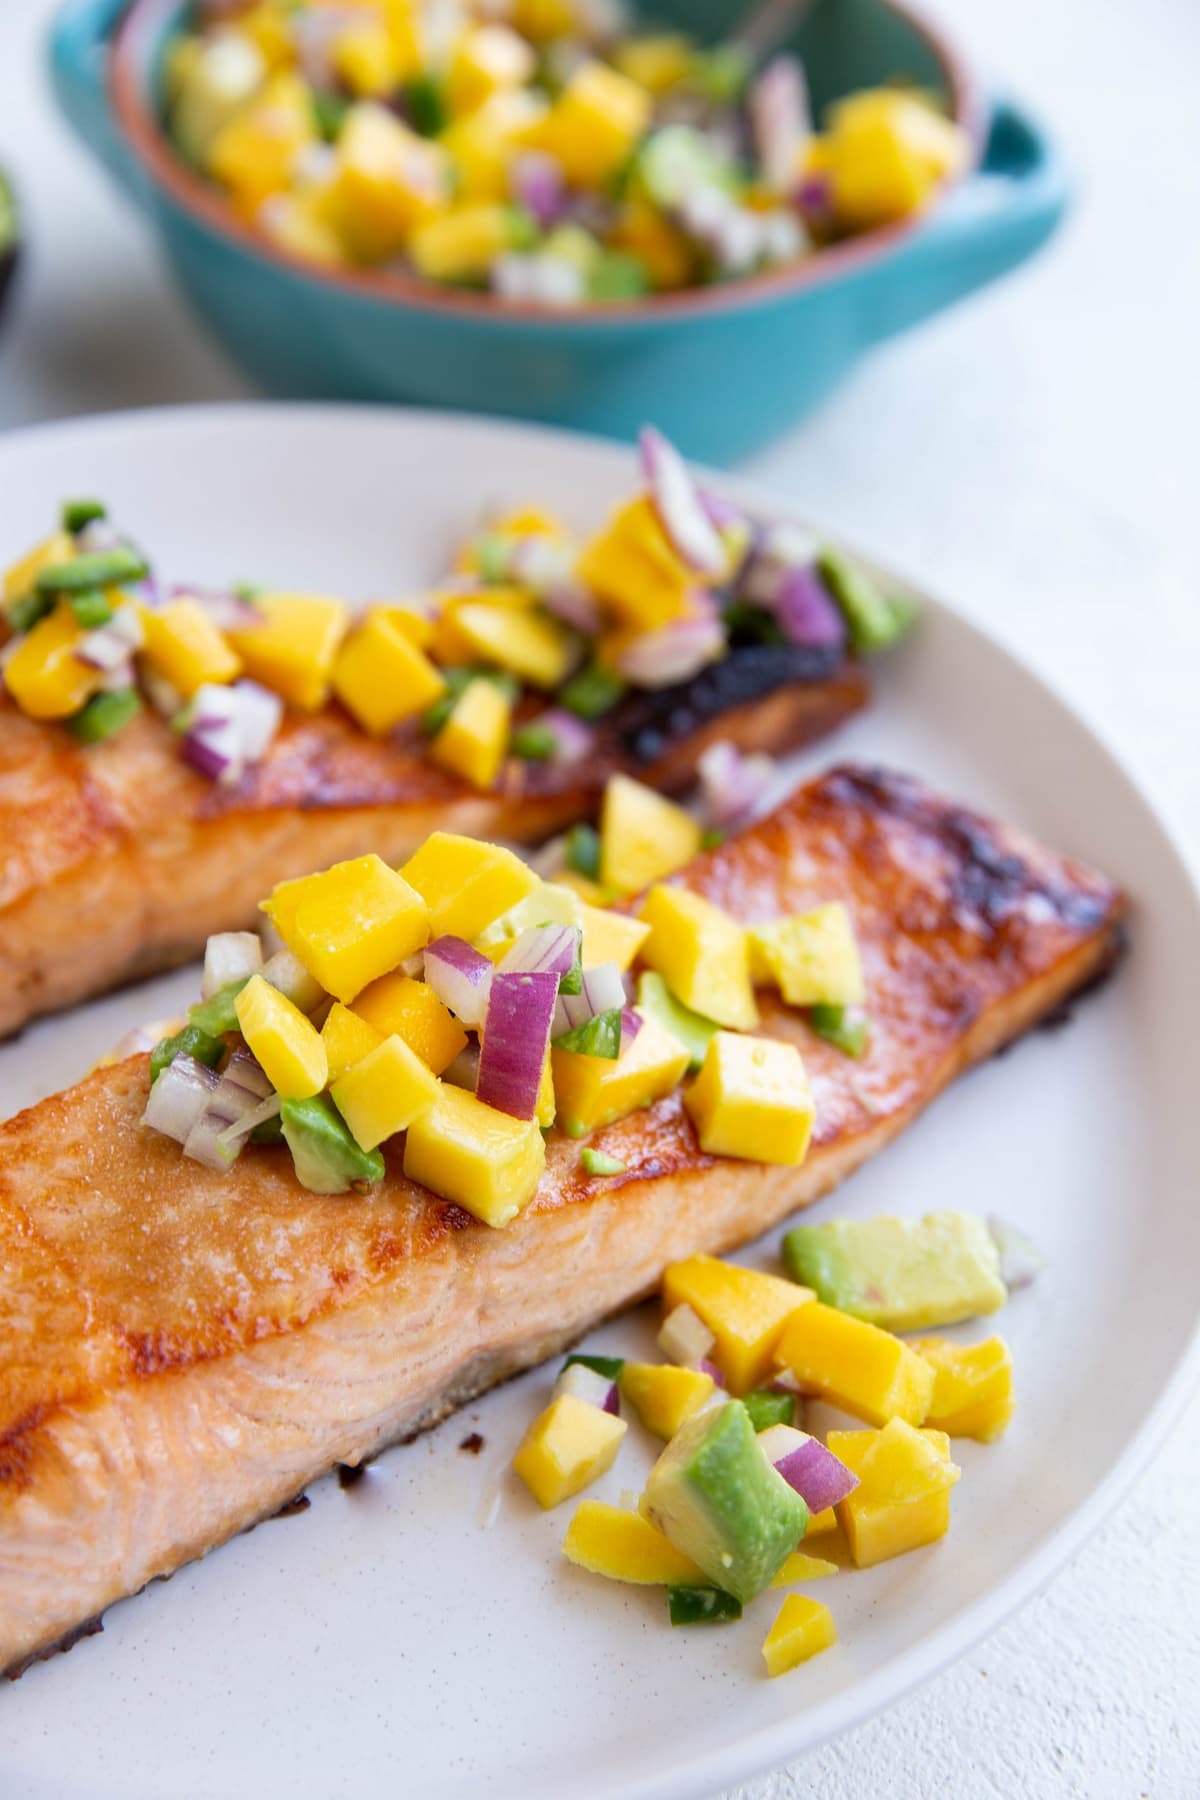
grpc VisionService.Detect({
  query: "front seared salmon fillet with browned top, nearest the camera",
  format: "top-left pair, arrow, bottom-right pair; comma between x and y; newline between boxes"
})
0,767 -> 1124,1670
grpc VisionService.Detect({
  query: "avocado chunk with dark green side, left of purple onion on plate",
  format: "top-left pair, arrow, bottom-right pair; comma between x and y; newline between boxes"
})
640,1400 -> 808,1604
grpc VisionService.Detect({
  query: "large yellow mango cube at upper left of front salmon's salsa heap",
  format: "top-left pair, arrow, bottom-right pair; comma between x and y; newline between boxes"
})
263,855 -> 428,1022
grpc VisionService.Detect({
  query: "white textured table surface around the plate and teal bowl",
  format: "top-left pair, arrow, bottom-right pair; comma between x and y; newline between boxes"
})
0,0 -> 1200,1800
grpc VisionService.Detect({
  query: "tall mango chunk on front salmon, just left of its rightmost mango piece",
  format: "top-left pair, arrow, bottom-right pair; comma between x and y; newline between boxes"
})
639,887 -> 759,1031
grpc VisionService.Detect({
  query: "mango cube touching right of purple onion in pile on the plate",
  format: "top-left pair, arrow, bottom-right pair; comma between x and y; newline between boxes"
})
826,1420 -> 961,1570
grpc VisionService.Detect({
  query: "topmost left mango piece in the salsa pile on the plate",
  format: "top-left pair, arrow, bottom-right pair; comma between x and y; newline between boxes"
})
662,1256 -> 813,1395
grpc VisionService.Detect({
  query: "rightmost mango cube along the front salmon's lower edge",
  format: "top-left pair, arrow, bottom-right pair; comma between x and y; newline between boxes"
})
684,1031 -> 817,1165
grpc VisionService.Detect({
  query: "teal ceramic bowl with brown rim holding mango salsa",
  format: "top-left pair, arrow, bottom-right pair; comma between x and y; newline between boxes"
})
50,0 -> 1067,463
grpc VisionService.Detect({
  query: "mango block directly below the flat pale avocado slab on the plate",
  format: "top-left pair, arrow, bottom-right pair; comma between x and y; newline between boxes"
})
775,1300 -> 934,1426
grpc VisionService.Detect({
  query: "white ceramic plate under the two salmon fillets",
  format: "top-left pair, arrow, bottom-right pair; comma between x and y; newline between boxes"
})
0,407 -> 1200,1800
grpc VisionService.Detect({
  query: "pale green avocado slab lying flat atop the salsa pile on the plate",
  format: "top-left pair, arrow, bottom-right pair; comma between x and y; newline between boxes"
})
783,1213 -> 1007,1332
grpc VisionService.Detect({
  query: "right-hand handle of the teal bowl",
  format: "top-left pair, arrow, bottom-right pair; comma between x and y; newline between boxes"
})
871,99 -> 1070,338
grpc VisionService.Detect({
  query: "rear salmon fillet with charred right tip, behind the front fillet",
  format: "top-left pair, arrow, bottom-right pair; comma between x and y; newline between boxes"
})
0,646 -> 867,1037
